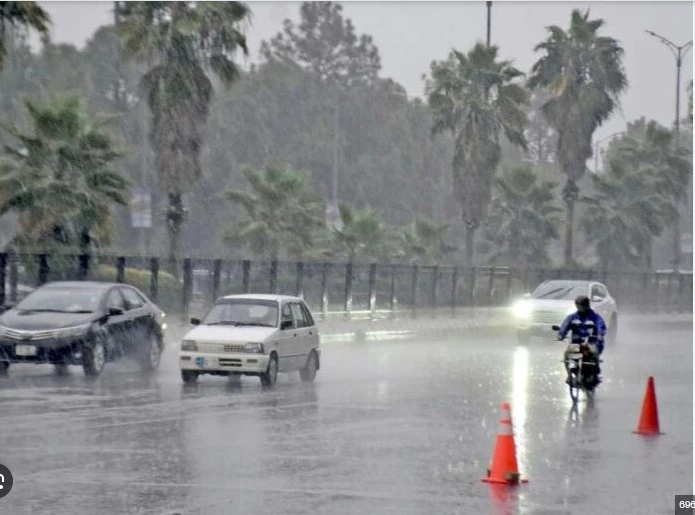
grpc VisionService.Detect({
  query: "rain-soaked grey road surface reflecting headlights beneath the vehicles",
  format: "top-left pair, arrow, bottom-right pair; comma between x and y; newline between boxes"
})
0,325 -> 693,515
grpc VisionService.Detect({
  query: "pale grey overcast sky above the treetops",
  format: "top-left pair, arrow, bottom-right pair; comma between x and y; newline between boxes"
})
39,1 -> 693,145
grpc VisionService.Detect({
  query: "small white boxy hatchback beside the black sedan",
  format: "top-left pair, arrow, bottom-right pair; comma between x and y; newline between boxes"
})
179,294 -> 321,387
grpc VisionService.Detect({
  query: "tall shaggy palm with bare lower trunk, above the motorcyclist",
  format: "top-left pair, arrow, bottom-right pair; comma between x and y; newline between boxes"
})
528,9 -> 627,264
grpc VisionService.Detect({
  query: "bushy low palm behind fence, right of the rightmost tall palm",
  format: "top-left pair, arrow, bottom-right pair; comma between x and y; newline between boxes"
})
583,158 -> 675,270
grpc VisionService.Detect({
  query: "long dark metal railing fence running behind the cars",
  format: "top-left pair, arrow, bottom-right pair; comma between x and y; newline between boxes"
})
0,253 -> 693,319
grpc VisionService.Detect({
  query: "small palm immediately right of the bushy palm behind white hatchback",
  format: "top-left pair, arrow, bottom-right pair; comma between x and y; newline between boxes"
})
333,203 -> 395,263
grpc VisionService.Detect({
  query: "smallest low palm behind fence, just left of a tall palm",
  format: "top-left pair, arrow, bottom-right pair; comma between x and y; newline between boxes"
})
400,215 -> 454,264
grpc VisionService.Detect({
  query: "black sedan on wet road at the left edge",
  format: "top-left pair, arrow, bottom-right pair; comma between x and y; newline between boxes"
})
0,281 -> 166,376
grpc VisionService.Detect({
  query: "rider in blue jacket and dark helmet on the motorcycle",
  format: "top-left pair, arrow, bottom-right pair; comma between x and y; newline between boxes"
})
558,295 -> 606,384
